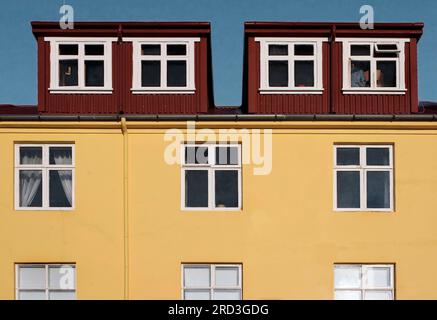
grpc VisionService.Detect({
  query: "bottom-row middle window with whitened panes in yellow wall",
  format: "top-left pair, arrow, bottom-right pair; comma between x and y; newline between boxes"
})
182,264 -> 242,300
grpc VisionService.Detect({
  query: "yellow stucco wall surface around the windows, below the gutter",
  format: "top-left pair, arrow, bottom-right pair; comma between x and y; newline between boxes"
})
0,122 -> 437,299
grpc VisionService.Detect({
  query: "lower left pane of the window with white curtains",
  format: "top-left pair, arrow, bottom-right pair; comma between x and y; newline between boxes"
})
19,170 -> 42,207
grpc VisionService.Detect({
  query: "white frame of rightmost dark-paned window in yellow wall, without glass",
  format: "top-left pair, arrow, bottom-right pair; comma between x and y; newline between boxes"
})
333,144 -> 394,212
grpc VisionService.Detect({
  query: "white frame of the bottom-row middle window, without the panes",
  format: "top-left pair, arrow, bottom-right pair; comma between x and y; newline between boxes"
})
181,263 -> 243,300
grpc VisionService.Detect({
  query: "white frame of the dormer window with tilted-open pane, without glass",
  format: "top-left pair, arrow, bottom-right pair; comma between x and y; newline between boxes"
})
336,38 -> 410,95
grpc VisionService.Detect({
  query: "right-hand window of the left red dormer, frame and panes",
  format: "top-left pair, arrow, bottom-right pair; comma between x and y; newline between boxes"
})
128,38 -> 200,94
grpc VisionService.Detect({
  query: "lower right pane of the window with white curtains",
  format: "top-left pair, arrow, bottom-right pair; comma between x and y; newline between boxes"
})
49,170 -> 73,208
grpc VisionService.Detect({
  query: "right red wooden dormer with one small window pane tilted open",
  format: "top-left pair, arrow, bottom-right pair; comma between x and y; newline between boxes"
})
243,22 -> 423,114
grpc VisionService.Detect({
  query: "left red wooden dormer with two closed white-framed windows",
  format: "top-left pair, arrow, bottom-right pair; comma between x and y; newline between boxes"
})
32,22 -> 212,114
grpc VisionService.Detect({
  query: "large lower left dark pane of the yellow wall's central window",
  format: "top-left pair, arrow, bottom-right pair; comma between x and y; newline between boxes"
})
185,170 -> 208,208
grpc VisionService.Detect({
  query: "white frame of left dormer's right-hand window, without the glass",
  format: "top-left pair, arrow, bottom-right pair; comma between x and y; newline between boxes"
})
124,38 -> 200,94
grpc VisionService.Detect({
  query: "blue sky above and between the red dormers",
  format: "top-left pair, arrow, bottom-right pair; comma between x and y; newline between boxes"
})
0,0 -> 437,105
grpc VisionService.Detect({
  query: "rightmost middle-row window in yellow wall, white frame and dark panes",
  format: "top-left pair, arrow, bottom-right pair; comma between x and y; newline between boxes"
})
334,145 -> 393,211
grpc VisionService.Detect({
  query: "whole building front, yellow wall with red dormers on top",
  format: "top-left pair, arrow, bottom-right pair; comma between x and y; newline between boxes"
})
0,22 -> 437,300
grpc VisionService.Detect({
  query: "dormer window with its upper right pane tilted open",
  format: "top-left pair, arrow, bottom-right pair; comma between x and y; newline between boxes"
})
338,39 -> 409,94
